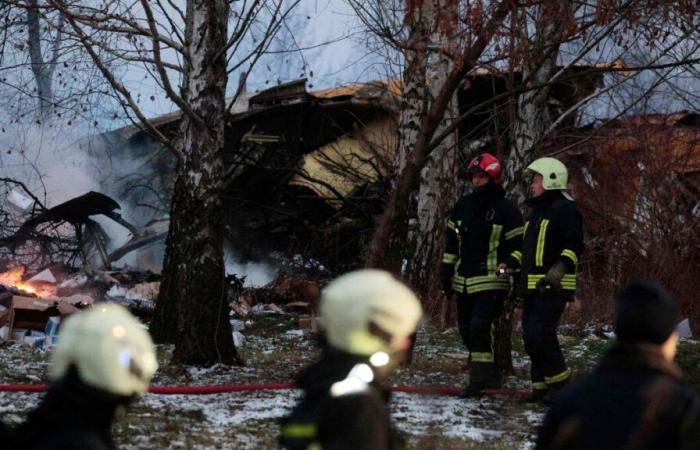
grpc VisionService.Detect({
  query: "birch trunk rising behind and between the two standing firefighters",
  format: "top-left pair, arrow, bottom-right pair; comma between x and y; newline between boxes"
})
494,0 -> 570,374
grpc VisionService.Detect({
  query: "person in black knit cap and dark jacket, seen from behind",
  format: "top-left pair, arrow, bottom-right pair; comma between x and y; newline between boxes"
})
536,280 -> 700,450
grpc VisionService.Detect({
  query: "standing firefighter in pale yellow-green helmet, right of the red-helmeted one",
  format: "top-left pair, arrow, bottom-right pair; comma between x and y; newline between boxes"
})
500,158 -> 583,403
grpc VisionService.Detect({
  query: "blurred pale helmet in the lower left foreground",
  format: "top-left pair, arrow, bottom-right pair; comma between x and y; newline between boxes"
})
51,304 -> 158,396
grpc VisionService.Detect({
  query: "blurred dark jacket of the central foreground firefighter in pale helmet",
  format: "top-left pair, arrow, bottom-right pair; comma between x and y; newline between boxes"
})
278,348 -> 403,450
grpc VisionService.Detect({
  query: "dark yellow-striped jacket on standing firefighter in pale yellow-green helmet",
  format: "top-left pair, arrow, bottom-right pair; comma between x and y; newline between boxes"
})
506,190 -> 583,293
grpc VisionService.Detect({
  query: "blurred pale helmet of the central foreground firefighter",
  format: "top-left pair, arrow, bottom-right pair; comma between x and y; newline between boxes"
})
319,269 -> 422,356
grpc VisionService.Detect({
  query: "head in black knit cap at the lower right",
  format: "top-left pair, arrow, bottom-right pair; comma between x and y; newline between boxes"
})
615,280 -> 678,360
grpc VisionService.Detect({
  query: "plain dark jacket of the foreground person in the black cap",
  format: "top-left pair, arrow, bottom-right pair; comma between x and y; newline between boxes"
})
536,343 -> 700,450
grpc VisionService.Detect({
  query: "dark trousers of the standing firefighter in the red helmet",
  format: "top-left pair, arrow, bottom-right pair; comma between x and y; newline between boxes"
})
457,290 -> 508,387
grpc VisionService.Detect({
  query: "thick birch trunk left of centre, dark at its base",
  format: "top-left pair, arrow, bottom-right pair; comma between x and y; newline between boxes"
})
151,0 -> 240,365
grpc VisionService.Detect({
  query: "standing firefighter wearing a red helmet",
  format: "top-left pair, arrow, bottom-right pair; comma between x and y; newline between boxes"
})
441,153 -> 523,398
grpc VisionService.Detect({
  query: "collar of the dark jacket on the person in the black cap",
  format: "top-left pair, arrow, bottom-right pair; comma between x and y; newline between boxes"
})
596,342 -> 683,380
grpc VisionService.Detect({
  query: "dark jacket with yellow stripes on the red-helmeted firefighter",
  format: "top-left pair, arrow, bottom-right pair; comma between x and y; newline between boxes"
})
441,183 -> 523,294
